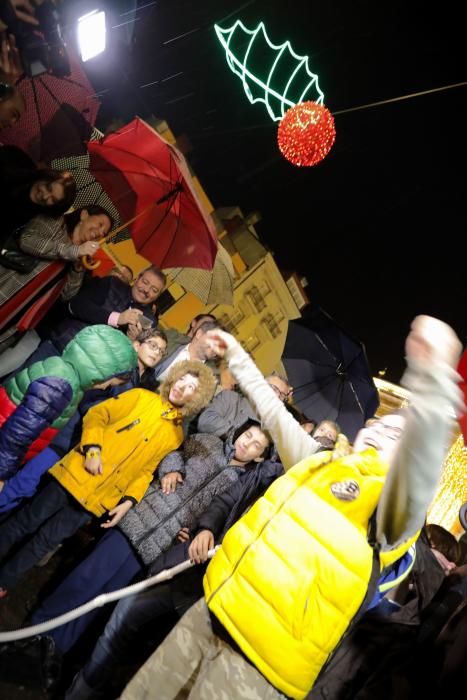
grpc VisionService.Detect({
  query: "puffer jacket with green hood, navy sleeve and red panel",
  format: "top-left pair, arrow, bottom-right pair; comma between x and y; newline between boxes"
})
0,325 -> 137,478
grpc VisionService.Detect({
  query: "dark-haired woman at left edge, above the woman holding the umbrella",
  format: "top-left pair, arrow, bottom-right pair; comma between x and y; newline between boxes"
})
0,146 -> 76,248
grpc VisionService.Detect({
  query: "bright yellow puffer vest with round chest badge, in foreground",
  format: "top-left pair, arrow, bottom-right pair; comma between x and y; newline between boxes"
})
204,449 -> 416,698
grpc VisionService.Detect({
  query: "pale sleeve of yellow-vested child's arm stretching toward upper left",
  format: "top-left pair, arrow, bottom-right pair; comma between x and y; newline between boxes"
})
222,334 -> 321,470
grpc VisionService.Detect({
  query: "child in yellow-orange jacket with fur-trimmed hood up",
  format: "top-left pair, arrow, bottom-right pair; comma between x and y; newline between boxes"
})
0,361 -> 216,595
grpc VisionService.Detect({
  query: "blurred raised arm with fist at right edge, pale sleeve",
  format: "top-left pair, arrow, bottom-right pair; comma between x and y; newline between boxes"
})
377,316 -> 462,548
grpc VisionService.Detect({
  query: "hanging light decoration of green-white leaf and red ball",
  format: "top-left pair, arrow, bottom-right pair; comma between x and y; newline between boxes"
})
214,20 -> 336,166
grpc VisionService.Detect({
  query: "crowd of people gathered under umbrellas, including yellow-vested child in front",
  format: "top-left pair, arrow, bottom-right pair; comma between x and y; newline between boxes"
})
0,2 -> 467,700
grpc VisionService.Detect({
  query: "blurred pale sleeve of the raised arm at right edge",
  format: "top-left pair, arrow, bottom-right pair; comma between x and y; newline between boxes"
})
377,360 -> 462,549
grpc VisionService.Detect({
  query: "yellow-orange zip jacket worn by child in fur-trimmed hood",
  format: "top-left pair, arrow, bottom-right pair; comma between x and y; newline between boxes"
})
50,389 -> 183,516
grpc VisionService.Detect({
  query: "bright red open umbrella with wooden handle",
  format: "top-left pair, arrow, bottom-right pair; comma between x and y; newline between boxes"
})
88,118 -> 217,270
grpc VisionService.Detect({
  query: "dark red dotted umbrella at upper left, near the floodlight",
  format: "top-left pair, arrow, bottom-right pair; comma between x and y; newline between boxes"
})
1,50 -> 100,164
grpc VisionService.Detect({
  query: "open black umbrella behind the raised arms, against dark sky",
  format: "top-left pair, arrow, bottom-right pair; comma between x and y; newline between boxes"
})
282,310 -> 379,441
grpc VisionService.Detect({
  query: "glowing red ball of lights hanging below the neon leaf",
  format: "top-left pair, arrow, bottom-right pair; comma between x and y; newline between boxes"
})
277,102 -> 336,166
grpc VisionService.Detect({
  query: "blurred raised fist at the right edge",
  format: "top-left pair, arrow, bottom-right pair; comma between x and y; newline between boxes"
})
405,316 -> 462,369
